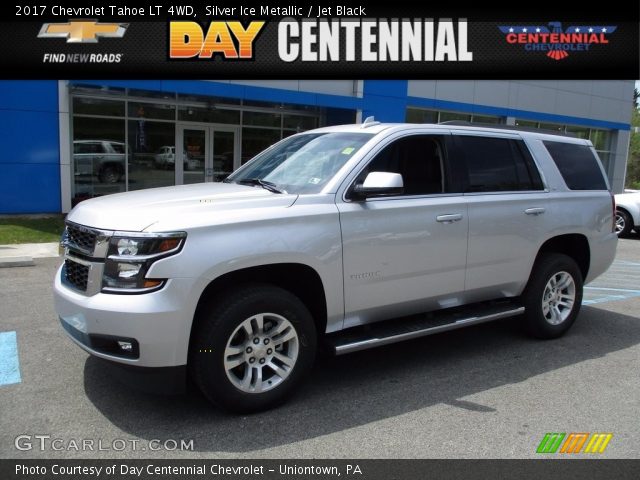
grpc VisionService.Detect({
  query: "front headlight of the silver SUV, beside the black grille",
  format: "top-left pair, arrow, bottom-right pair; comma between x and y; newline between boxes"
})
102,232 -> 187,293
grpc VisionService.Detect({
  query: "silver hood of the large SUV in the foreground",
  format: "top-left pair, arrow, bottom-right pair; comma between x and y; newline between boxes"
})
67,183 -> 297,231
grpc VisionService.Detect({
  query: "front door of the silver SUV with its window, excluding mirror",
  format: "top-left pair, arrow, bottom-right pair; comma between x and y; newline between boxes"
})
338,134 -> 468,327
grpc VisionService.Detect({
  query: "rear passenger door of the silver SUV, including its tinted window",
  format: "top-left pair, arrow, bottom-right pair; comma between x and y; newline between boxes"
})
452,131 -> 548,301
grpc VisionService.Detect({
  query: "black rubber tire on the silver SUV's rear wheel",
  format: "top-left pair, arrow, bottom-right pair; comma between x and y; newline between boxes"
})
522,253 -> 583,339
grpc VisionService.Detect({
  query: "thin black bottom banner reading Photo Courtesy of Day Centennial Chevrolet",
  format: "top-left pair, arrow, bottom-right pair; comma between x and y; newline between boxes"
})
0,459 -> 640,480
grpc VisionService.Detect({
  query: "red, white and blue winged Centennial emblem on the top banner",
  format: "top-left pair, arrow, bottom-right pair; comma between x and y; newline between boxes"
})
498,22 -> 617,60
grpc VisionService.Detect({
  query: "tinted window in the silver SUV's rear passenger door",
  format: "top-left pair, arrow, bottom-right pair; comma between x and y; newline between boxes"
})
457,135 -> 543,192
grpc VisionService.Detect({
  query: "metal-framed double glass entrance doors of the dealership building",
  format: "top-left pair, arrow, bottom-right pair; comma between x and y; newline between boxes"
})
176,125 -> 240,185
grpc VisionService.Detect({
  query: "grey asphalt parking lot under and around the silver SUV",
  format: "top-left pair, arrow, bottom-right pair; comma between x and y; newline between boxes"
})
0,237 -> 640,459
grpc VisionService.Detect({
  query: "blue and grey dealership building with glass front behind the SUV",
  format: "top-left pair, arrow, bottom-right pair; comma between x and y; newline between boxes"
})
0,80 -> 634,214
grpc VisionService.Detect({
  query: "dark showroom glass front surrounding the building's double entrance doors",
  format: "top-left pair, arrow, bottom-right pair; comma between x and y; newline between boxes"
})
70,84 -> 356,205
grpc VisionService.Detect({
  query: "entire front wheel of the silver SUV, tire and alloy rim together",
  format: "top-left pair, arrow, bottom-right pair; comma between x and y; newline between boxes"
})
190,285 -> 316,412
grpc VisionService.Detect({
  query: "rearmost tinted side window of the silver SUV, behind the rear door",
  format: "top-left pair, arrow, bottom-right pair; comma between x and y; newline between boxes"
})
543,141 -> 607,190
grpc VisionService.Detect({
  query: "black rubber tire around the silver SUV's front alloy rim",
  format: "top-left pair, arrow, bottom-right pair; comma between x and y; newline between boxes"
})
189,284 -> 317,413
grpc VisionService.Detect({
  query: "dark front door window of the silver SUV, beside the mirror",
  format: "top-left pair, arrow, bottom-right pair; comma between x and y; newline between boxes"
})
356,135 -> 445,195
